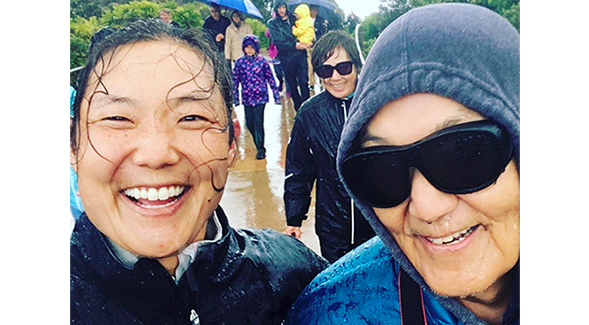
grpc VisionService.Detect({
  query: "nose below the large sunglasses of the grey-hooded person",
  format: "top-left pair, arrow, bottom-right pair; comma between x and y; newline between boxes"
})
409,170 -> 458,223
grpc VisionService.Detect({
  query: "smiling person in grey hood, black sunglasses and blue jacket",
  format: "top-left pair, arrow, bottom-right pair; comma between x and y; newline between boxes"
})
287,4 -> 520,325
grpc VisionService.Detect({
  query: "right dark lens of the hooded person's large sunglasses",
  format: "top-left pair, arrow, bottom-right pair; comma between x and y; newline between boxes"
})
420,131 -> 511,194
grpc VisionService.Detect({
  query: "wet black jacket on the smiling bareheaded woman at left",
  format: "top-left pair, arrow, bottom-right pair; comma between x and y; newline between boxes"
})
70,208 -> 327,325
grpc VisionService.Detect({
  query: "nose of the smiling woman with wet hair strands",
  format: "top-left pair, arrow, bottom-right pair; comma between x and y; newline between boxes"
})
132,126 -> 180,169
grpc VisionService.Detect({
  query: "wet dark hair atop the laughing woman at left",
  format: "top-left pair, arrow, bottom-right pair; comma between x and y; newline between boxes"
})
70,19 -> 234,155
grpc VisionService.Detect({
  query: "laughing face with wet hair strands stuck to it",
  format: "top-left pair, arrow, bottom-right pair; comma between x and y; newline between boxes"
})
72,41 -> 234,258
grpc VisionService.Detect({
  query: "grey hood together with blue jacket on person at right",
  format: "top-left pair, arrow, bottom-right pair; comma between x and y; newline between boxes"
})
287,3 -> 520,324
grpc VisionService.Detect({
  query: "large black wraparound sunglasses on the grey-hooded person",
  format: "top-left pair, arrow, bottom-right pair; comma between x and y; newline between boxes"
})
342,120 -> 513,208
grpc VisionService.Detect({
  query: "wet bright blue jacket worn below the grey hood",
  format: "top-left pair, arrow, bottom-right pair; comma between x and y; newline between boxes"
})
285,237 -> 519,325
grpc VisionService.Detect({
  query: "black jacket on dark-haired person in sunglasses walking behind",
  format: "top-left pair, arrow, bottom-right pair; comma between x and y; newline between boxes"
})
284,91 -> 374,262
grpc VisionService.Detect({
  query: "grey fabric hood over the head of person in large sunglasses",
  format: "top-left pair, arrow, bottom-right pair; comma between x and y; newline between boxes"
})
337,3 -> 520,322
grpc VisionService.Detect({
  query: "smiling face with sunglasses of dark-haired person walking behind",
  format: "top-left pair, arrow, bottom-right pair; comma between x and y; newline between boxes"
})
322,47 -> 358,98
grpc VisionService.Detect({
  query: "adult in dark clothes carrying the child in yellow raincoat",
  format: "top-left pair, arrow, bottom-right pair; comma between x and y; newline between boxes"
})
268,0 -> 311,111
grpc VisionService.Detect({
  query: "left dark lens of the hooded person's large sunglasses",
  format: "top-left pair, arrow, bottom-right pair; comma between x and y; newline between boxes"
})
342,152 -> 409,208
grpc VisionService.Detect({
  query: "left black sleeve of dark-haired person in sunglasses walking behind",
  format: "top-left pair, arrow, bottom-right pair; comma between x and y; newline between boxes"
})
284,112 -> 317,227
